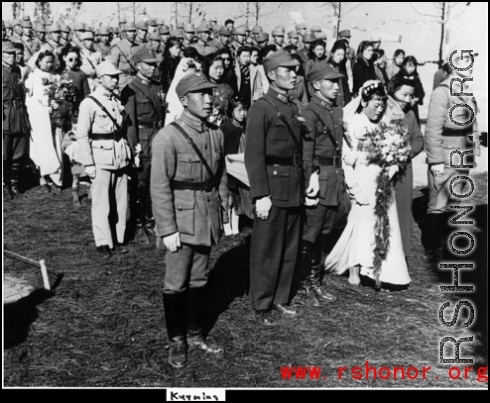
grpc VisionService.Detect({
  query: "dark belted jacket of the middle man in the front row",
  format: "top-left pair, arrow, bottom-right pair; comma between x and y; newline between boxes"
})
245,87 -> 303,207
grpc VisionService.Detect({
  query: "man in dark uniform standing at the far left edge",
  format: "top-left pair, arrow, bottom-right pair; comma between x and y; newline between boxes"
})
2,42 -> 30,198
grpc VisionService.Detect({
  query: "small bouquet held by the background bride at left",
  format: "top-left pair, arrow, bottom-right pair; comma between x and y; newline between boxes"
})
43,80 -> 77,130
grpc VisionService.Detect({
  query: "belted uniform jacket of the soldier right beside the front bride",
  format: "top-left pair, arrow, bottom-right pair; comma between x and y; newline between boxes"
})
302,94 -> 345,206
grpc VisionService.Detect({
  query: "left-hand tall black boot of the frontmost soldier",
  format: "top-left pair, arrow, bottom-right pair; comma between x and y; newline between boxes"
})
163,292 -> 187,368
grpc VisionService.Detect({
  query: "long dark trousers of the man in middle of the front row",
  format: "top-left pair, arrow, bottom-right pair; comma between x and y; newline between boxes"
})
250,206 -> 302,310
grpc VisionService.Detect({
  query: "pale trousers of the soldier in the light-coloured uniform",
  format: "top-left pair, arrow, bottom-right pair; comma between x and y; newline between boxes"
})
91,168 -> 128,248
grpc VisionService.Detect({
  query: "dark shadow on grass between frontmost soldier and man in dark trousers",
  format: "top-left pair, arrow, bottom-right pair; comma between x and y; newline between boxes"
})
204,236 -> 250,334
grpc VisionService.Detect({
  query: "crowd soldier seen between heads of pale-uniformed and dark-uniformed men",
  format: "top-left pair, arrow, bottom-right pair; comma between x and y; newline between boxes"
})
110,22 -> 141,90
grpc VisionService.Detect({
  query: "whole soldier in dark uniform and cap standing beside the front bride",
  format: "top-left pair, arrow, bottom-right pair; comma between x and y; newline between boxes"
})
296,63 -> 345,306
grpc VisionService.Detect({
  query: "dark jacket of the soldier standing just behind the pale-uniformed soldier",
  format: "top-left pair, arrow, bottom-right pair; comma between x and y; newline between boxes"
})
121,75 -> 163,151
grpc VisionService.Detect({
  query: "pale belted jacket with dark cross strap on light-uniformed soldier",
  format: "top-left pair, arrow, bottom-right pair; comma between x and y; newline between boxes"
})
77,87 -> 131,170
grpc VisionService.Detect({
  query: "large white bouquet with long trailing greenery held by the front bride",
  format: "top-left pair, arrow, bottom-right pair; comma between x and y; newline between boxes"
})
363,122 -> 411,288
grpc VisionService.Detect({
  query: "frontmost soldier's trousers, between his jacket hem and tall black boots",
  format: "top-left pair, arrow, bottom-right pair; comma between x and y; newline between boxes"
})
163,243 -> 211,294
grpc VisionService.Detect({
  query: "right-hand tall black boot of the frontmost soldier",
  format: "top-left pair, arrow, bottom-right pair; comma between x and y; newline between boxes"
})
187,287 -> 223,354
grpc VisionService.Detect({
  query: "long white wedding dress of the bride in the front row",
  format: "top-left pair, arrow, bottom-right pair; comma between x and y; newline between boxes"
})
325,112 -> 410,285
